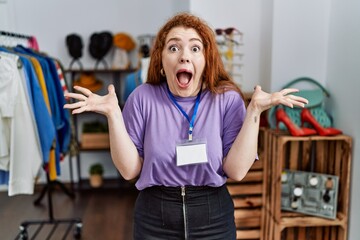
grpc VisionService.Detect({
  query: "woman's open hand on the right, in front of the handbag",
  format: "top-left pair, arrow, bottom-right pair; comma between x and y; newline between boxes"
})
249,85 -> 308,113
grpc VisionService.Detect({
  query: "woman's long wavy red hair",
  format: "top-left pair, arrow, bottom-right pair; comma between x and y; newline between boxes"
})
146,13 -> 243,96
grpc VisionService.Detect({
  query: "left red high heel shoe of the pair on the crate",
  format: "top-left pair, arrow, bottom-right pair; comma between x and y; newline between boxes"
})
276,108 -> 316,137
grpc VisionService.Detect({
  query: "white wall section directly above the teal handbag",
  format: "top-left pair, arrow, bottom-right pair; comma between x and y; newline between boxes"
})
271,0 -> 331,91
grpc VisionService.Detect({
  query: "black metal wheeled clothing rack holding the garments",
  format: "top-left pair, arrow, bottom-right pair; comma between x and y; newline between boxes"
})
0,31 -> 82,240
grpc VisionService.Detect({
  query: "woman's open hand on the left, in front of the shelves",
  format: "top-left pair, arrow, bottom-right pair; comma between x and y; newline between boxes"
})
64,84 -> 120,116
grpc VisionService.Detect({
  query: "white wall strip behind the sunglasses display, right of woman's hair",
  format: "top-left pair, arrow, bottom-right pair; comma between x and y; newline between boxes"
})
190,0 -> 262,92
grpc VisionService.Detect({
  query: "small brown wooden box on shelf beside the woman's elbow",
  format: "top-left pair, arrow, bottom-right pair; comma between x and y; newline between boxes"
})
81,133 -> 110,149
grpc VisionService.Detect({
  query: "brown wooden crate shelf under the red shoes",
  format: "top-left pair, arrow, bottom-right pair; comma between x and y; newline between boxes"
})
262,130 -> 352,240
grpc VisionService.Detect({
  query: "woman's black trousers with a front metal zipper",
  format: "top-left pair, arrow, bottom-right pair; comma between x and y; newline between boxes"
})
134,185 -> 236,240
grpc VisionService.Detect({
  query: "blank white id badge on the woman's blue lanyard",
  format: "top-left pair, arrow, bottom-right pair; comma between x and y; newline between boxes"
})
176,139 -> 208,166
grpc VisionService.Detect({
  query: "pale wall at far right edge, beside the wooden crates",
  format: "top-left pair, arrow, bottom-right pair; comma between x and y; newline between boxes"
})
326,0 -> 360,240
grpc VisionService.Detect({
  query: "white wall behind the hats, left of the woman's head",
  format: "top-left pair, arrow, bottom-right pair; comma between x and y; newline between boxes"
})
9,0 -> 174,68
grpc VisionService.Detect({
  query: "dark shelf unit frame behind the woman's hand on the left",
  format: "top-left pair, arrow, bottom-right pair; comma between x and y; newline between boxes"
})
65,69 -> 137,190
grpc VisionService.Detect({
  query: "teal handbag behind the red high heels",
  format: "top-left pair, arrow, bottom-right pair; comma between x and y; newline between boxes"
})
268,77 -> 332,130
